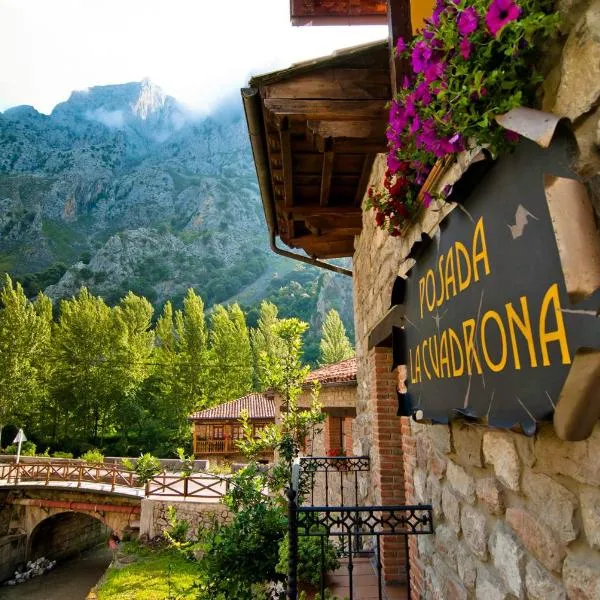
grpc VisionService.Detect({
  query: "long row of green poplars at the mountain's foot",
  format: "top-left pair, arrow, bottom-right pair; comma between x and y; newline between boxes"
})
0,276 -> 314,456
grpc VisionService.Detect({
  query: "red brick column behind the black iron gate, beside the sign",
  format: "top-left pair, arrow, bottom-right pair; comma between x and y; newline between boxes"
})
369,348 -> 406,583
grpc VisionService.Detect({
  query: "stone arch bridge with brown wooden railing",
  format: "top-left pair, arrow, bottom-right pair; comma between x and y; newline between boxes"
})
0,461 -> 229,581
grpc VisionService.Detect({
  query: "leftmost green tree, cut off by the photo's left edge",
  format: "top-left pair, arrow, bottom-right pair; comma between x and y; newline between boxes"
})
0,275 -> 52,440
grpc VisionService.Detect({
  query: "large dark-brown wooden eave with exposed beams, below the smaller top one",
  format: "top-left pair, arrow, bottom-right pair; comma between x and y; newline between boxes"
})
242,41 -> 392,259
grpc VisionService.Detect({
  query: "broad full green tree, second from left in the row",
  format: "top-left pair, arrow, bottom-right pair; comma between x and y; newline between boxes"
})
52,288 -> 152,443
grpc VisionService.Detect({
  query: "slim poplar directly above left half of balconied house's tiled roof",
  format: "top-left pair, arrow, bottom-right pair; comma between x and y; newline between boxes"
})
209,304 -> 253,405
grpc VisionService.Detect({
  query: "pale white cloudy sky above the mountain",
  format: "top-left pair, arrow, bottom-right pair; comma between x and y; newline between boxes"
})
0,0 -> 387,113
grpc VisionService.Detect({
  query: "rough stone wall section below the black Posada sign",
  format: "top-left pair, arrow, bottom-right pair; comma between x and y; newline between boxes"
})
408,422 -> 600,600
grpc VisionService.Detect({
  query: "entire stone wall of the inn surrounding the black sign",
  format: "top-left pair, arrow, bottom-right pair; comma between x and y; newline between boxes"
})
353,0 -> 600,600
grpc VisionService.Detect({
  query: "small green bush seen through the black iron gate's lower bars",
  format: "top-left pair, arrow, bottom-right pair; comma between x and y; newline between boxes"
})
277,533 -> 340,586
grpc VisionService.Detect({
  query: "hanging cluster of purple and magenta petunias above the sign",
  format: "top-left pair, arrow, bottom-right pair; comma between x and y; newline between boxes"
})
367,0 -> 558,236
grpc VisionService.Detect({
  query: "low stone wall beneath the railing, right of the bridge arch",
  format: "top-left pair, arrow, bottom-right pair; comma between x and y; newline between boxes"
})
140,498 -> 230,539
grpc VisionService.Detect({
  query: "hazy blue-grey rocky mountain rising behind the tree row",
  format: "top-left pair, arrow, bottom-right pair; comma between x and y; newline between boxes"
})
0,80 -> 352,360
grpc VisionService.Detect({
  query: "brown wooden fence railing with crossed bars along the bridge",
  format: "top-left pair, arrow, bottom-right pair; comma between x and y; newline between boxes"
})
0,461 -> 229,502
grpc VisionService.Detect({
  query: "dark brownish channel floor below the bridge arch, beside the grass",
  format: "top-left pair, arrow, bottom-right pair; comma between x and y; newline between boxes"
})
0,544 -> 111,600
